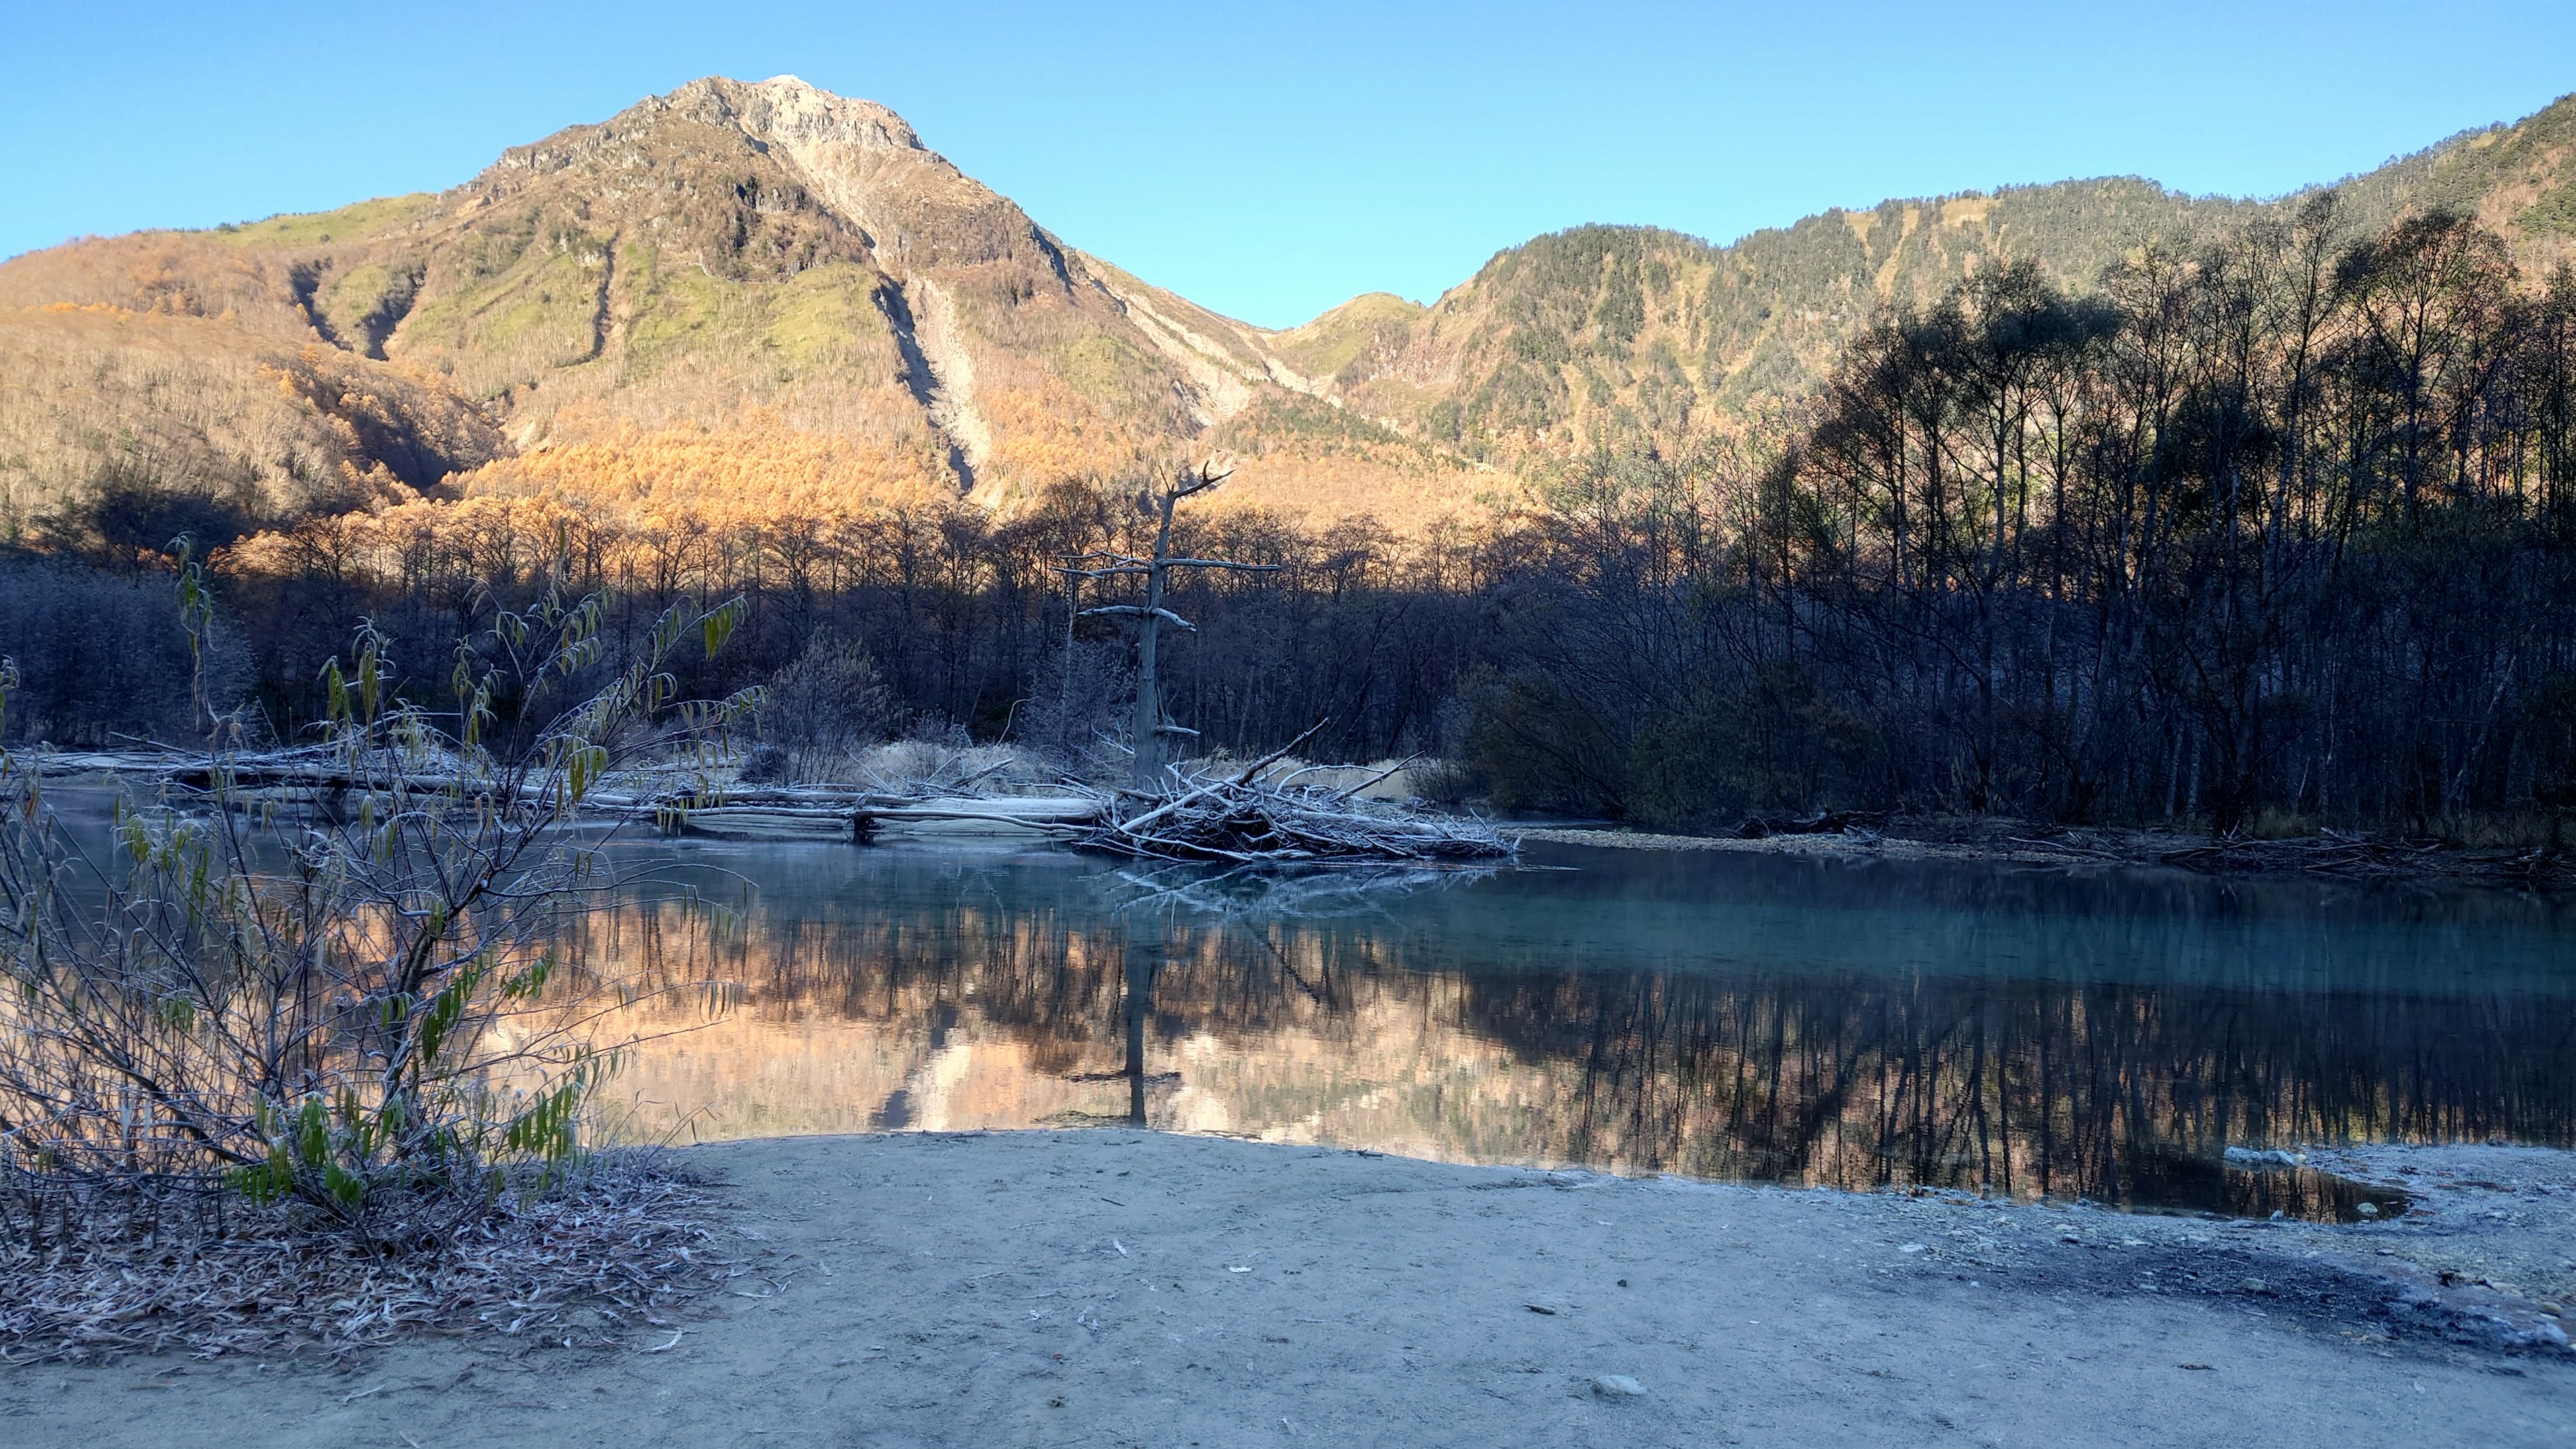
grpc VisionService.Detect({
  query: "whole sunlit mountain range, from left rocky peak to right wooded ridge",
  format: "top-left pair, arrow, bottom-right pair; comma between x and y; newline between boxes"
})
0,77 -> 2576,539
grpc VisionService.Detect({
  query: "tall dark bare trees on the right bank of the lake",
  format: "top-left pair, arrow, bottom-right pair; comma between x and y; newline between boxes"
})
1468,199 -> 2576,830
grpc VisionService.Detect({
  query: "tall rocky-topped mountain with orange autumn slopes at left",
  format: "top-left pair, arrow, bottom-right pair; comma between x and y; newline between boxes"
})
0,77 -> 1471,534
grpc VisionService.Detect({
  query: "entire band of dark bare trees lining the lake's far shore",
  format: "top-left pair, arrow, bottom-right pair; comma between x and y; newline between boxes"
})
0,193 -> 2576,838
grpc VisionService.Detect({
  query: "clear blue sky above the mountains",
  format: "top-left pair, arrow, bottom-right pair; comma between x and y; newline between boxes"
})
0,0 -> 2576,325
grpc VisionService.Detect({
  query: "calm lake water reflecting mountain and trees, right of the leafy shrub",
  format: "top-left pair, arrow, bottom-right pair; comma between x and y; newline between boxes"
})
582,843 -> 2576,1217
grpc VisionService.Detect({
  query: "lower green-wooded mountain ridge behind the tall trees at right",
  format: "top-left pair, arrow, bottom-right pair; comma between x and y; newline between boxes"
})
1339,98 -> 2576,464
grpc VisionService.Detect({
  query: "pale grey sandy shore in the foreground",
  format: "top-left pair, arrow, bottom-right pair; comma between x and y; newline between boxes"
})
0,1132 -> 2576,1449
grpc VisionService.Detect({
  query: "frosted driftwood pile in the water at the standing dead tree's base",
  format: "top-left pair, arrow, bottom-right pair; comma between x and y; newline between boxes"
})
1071,730 -> 1520,864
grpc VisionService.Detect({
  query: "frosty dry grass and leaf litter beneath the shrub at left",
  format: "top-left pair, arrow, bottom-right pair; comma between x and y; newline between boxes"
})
0,1155 -> 742,1364
